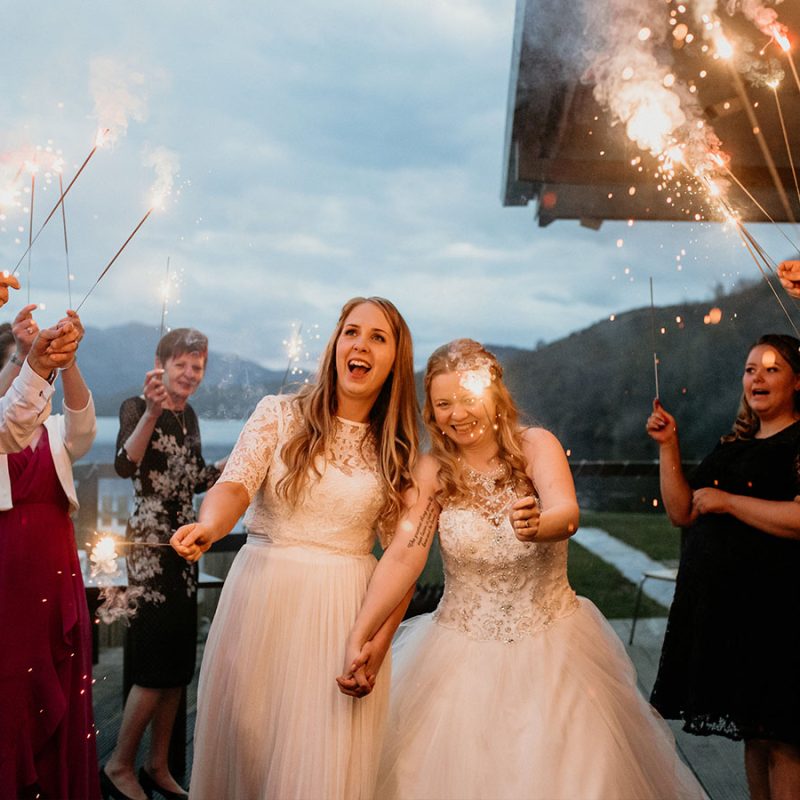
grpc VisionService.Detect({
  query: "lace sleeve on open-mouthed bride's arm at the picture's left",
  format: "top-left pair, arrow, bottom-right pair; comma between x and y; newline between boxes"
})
219,395 -> 283,500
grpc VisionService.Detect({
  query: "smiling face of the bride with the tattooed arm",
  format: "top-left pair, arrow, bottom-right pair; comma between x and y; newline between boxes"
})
430,371 -> 497,448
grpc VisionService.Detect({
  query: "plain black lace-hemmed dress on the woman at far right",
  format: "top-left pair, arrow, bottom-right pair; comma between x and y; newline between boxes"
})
651,422 -> 800,745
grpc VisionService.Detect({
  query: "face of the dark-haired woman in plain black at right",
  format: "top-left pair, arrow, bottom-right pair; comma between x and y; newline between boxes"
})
742,344 -> 800,421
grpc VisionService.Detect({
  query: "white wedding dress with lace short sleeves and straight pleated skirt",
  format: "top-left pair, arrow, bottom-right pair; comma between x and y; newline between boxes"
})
190,396 -> 391,800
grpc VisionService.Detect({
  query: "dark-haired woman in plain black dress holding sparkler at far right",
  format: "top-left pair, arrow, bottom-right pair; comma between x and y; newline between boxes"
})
647,334 -> 800,800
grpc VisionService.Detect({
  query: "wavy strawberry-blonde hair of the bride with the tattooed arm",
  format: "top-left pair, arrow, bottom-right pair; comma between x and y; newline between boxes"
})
422,339 -> 533,501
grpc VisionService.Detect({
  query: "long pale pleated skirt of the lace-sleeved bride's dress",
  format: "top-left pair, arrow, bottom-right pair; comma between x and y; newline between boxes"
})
190,542 -> 391,800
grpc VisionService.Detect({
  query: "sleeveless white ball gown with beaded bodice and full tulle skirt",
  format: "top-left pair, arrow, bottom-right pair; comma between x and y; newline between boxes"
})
375,471 -> 705,800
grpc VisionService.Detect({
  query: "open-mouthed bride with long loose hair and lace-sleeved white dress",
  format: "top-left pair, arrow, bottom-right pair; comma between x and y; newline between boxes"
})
172,298 -> 417,800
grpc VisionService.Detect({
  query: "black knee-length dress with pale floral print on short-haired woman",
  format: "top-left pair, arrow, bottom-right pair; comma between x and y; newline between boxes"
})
114,397 -> 220,689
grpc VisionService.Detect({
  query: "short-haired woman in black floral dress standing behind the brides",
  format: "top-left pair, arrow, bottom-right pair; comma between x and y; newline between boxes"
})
100,328 -> 225,800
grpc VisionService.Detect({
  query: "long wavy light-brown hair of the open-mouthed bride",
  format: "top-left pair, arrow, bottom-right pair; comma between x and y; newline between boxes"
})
276,297 -> 419,534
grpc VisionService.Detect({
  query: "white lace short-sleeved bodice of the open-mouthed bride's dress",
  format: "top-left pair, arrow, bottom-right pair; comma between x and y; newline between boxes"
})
220,395 -> 384,555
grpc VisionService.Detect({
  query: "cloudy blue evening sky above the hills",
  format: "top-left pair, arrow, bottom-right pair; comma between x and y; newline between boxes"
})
0,0 -> 785,368
